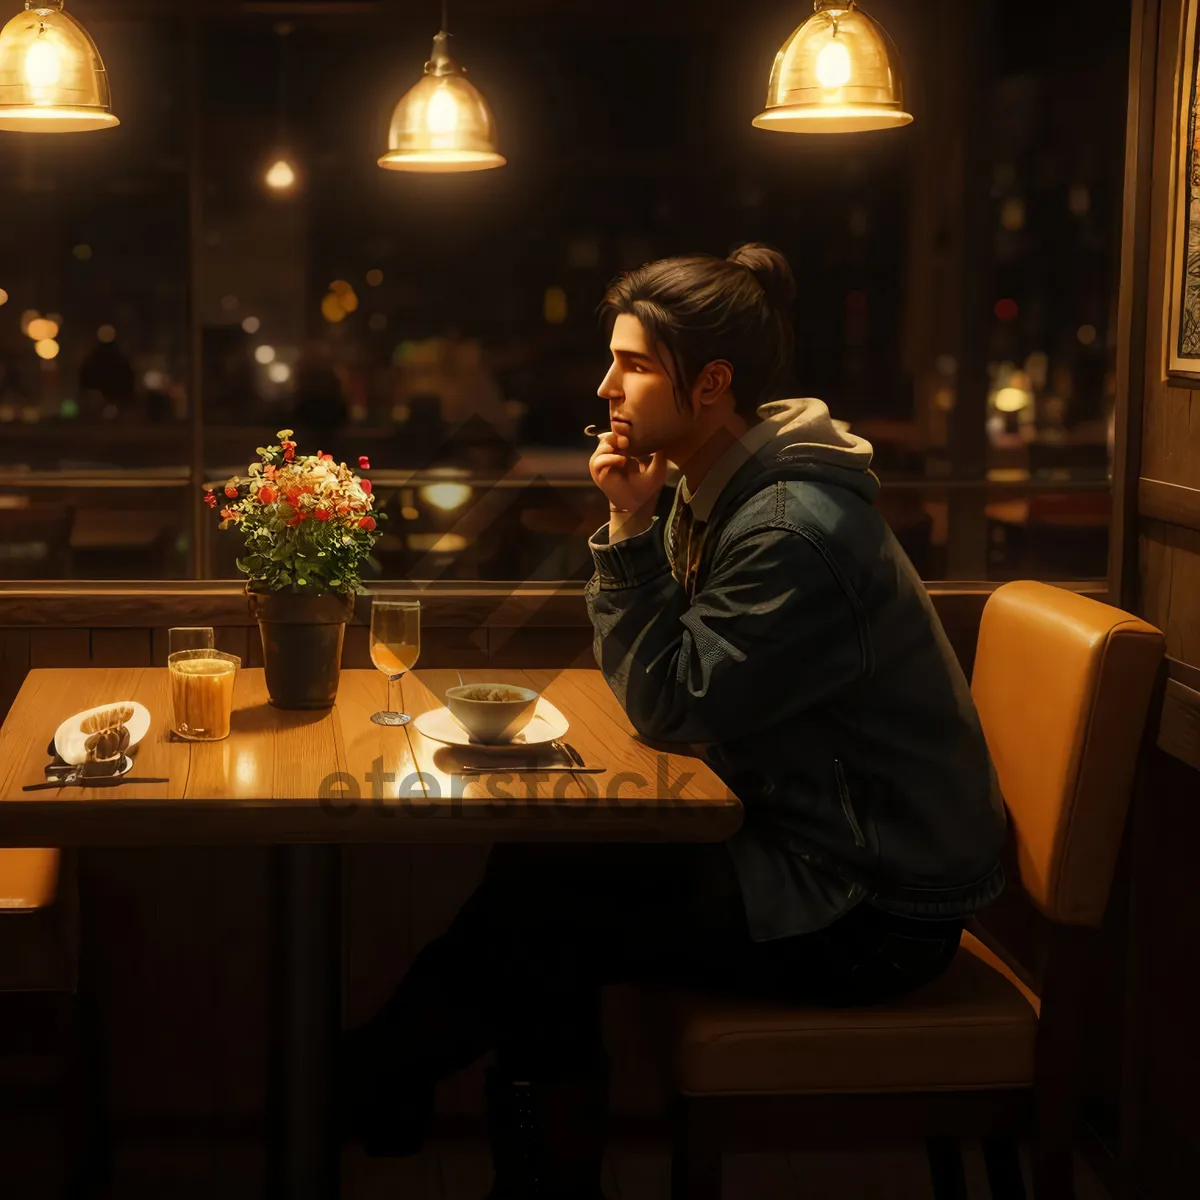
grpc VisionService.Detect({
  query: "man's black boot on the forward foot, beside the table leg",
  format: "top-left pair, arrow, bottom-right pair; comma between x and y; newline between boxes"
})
337,1021 -> 434,1158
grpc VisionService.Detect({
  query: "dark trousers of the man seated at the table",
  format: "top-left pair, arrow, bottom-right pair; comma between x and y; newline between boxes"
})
372,845 -> 962,1082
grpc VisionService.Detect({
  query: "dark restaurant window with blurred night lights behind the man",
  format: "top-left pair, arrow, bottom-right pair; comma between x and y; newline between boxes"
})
0,0 -> 1128,581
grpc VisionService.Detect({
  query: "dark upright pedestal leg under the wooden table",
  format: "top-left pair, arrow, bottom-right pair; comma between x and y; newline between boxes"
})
268,846 -> 342,1200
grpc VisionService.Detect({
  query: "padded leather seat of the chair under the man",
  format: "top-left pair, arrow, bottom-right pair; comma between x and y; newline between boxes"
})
660,932 -> 1038,1096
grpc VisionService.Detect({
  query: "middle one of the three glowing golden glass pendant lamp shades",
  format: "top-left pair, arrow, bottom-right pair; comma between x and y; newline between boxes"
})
379,32 -> 506,173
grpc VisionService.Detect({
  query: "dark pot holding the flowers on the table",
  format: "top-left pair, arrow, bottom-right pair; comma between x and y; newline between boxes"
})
246,588 -> 354,708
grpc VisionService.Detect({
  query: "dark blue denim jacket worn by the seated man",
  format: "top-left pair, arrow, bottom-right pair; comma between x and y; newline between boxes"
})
586,401 -> 1006,941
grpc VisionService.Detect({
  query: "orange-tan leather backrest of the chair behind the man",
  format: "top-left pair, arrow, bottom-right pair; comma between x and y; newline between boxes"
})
971,581 -> 1164,925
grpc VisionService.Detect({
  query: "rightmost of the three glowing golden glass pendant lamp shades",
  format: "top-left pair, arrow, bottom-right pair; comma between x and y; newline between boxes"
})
752,0 -> 912,133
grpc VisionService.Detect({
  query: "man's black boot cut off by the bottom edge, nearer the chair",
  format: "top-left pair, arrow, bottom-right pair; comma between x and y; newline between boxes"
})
487,1064 -> 608,1200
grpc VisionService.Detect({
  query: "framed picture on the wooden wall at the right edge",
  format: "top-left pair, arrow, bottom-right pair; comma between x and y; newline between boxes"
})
1164,0 -> 1200,388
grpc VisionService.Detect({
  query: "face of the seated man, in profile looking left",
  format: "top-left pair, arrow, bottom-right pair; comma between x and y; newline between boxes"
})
598,313 -> 692,457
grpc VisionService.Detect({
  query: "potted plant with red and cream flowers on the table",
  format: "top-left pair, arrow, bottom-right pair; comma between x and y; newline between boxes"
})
204,430 -> 385,708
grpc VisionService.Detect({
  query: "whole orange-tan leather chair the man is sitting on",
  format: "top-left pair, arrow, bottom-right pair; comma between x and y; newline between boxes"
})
655,582 -> 1163,1200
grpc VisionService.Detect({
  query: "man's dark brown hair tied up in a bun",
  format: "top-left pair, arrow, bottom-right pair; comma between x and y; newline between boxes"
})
600,241 -> 796,416
